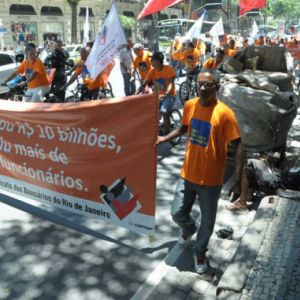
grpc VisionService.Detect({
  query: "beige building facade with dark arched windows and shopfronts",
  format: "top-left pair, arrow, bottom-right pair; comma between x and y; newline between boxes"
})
0,0 -> 182,47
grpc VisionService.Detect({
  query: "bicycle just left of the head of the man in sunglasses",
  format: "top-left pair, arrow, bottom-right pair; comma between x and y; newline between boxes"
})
178,66 -> 201,105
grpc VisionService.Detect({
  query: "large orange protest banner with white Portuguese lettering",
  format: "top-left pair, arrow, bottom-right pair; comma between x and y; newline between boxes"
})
0,95 -> 158,234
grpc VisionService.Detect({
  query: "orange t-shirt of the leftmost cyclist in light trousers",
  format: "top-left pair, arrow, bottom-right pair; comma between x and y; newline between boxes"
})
18,58 -> 49,89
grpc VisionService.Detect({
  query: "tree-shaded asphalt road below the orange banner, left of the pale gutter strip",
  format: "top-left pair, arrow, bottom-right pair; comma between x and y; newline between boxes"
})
0,63 -> 188,300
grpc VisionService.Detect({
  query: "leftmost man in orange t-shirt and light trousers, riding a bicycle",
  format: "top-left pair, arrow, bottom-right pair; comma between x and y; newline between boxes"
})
4,43 -> 50,102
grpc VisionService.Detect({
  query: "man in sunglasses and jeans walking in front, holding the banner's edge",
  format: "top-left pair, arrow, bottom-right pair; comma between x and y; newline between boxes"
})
156,72 -> 243,273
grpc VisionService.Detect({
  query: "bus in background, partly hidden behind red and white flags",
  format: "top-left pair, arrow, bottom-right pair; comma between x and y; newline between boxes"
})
156,19 -> 216,53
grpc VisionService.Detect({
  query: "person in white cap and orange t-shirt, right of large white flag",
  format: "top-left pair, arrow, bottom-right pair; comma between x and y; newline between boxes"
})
132,43 -> 152,80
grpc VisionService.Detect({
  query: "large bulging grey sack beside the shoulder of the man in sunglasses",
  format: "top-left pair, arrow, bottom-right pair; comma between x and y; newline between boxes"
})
218,82 -> 297,152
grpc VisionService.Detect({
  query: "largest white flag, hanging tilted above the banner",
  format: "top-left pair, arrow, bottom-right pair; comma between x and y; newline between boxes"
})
85,2 -> 127,79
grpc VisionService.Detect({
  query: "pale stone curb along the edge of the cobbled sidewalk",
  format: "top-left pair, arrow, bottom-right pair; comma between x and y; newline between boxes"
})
217,196 -> 279,297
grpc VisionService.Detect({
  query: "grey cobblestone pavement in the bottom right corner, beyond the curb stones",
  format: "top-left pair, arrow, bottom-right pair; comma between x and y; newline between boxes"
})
240,198 -> 300,300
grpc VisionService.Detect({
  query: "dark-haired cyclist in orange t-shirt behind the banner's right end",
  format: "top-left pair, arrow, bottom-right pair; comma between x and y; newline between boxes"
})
136,52 -> 176,134
